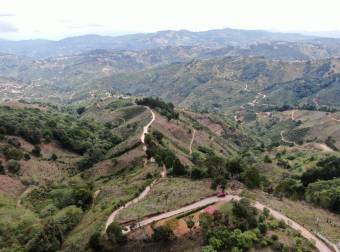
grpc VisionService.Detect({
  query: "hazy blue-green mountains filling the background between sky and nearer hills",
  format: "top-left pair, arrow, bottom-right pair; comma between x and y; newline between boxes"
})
0,29 -> 340,110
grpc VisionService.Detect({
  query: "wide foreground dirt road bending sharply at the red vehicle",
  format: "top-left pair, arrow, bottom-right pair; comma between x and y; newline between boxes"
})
126,195 -> 332,252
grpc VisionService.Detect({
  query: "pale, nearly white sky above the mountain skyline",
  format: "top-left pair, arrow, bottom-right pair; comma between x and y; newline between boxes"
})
0,0 -> 340,39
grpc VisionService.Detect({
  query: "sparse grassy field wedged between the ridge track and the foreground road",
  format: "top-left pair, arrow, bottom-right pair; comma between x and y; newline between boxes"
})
117,178 -> 214,222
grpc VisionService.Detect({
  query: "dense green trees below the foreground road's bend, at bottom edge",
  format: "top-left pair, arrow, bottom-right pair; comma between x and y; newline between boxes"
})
200,199 -> 309,252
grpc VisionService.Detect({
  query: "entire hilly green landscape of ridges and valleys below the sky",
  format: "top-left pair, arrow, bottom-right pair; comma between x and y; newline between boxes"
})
0,26 -> 340,252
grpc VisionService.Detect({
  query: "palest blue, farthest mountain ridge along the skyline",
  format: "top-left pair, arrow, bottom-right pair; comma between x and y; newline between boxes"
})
0,28 -> 339,58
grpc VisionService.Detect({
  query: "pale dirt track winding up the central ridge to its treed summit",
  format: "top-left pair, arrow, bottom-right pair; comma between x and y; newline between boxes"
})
104,106 -> 159,231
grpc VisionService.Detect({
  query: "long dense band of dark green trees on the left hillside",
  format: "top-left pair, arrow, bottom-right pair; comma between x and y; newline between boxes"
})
0,106 -> 120,157
